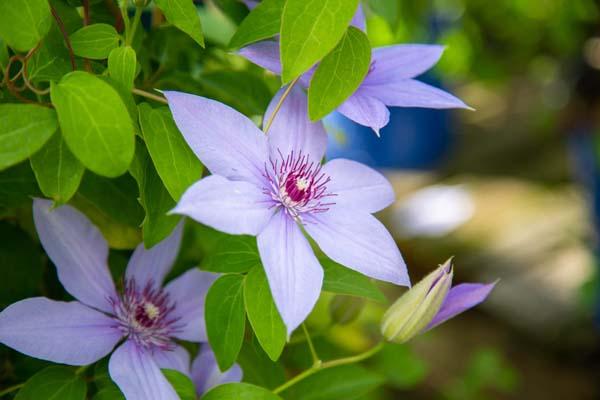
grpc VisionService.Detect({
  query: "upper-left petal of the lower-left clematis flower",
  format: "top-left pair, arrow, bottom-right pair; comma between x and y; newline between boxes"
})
33,199 -> 116,313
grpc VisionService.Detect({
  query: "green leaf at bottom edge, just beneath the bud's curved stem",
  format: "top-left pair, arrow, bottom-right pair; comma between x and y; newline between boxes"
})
283,365 -> 384,400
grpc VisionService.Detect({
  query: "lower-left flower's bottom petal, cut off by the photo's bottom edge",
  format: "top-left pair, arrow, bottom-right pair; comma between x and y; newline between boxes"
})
108,340 -> 179,400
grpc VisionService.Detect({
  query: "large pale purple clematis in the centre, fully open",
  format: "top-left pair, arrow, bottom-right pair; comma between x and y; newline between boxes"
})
164,88 -> 409,333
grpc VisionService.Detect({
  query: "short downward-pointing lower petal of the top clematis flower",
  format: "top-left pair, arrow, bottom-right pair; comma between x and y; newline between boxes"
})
337,88 -> 390,136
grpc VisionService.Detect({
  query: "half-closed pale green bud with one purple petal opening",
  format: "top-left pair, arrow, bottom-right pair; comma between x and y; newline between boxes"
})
381,259 -> 496,343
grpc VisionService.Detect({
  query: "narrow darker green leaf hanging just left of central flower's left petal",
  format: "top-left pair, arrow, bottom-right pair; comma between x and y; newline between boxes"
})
130,144 -> 181,248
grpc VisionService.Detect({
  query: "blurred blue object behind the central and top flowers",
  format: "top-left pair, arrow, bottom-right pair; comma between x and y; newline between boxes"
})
325,78 -> 453,170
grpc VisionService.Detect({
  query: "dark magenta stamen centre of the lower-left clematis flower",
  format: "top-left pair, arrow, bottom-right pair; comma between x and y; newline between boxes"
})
113,279 -> 179,349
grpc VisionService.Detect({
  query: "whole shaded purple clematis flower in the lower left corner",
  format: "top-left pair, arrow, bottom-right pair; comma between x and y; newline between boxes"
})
0,199 -> 216,400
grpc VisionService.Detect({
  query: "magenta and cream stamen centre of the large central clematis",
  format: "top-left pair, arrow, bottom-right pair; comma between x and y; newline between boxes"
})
263,151 -> 335,222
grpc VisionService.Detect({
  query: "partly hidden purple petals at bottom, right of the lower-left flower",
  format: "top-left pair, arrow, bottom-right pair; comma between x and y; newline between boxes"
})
192,344 -> 242,396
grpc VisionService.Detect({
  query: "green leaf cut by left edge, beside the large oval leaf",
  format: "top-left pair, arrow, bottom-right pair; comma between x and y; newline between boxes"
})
0,104 -> 58,170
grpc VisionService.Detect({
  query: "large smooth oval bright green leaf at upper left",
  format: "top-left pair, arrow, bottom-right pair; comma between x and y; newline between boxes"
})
50,71 -> 135,177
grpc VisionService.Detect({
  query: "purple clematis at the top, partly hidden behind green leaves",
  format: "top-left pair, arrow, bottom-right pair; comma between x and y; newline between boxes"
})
239,8 -> 471,136
